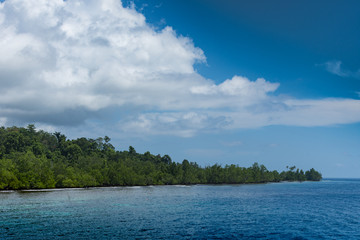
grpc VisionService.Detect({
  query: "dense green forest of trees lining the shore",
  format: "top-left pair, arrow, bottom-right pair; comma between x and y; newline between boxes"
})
0,125 -> 321,189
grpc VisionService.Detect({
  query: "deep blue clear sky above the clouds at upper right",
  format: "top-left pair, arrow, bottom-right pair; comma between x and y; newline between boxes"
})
129,0 -> 360,98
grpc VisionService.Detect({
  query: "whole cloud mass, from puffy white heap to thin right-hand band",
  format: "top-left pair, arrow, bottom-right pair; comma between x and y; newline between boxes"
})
0,0 -> 360,137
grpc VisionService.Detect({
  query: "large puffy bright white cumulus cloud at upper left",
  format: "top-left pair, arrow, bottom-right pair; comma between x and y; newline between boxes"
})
0,0 -> 205,115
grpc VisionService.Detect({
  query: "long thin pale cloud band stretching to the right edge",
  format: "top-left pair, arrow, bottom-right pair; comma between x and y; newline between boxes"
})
119,96 -> 360,137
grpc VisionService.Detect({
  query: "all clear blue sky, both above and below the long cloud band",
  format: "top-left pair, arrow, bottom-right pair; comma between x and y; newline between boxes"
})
125,0 -> 360,177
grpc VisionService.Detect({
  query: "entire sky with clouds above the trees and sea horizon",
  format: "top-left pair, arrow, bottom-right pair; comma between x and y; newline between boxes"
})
0,0 -> 360,178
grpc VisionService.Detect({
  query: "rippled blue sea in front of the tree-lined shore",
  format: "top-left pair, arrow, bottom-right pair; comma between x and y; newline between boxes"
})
0,179 -> 360,239
